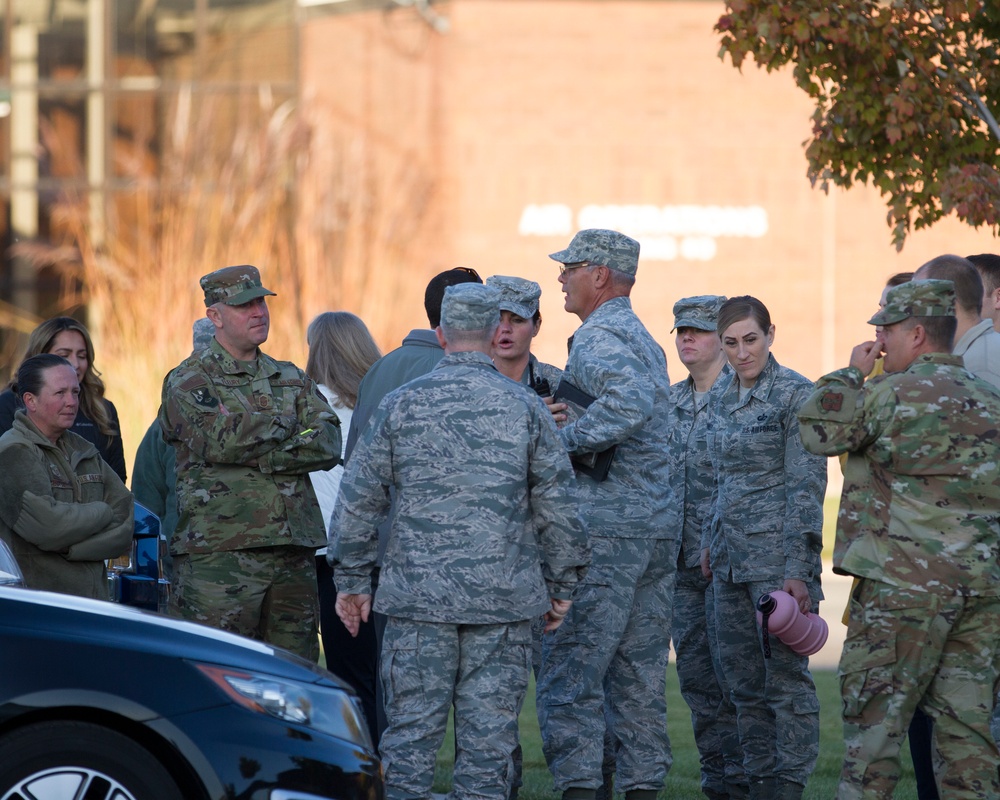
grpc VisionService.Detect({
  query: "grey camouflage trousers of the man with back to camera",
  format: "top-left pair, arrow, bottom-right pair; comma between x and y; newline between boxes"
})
379,617 -> 531,800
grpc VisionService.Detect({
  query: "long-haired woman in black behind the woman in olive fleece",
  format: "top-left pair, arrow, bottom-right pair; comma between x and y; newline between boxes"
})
0,317 -> 126,483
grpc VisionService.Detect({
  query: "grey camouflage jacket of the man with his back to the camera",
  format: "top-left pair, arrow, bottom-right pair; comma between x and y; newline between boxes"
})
328,352 -> 589,625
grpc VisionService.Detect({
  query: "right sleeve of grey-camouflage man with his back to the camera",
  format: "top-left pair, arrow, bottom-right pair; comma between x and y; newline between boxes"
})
528,408 -> 590,600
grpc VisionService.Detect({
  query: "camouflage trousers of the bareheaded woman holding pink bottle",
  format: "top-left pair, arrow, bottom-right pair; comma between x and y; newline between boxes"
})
712,572 -> 819,786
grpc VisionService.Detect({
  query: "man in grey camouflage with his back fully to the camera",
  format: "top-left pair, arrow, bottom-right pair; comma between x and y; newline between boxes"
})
328,283 -> 588,800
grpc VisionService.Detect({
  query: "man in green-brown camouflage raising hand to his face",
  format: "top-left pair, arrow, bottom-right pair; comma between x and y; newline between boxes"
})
799,280 -> 1000,800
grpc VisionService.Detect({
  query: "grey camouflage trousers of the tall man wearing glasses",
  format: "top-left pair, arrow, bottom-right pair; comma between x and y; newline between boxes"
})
537,536 -> 677,792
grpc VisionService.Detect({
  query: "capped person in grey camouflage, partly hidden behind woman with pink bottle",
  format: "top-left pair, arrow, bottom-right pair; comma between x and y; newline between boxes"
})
668,295 -> 747,800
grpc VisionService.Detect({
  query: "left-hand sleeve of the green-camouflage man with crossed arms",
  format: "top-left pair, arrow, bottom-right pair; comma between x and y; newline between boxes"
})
158,368 -> 297,466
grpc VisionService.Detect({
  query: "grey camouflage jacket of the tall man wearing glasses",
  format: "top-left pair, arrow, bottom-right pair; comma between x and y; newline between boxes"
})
553,297 -> 679,539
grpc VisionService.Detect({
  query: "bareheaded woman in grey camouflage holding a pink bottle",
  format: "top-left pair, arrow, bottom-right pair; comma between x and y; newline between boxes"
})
702,296 -> 826,800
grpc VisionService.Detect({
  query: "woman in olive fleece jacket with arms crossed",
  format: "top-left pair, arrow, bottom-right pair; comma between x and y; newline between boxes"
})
0,353 -> 132,600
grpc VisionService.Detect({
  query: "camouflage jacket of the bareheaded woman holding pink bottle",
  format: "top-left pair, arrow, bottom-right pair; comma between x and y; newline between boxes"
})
702,355 -> 826,588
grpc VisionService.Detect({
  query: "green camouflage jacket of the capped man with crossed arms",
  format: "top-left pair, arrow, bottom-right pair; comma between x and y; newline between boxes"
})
159,339 -> 341,554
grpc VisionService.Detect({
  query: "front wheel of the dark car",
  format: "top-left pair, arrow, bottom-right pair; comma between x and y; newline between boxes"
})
0,722 -> 183,800
